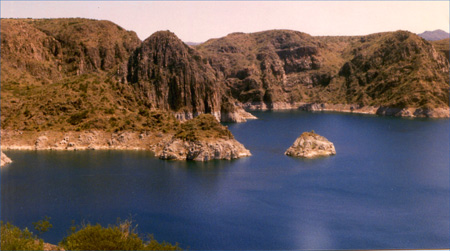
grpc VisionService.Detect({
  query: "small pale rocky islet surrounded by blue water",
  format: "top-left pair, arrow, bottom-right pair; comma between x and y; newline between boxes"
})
285,131 -> 336,158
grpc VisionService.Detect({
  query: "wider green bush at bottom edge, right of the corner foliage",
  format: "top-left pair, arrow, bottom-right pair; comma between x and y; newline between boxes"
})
60,221 -> 181,250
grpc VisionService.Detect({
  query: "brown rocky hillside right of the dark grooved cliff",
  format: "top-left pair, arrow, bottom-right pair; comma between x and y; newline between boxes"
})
196,30 -> 449,116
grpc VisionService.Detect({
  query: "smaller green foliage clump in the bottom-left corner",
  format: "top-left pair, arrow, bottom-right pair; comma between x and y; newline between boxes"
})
1,222 -> 44,250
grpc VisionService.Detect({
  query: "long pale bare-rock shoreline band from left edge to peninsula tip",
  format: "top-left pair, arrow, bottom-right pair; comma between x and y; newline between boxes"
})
1,130 -> 251,163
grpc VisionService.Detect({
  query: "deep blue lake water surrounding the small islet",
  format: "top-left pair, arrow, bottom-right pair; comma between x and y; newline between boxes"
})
1,111 -> 450,250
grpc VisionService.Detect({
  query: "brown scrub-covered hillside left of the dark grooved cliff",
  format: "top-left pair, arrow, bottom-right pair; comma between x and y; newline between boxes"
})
1,19 -> 144,130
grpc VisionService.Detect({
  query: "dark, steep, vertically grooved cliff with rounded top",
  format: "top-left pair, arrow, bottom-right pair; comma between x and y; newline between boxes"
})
126,31 -> 255,122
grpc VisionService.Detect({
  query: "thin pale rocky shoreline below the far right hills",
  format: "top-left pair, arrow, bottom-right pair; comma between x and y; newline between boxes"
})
243,102 -> 450,118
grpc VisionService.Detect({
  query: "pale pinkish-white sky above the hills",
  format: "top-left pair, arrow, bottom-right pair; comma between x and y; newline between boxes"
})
0,0 -> 450,42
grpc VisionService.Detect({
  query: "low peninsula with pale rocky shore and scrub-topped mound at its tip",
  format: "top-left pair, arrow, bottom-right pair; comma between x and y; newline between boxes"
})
1,113 -> 251,163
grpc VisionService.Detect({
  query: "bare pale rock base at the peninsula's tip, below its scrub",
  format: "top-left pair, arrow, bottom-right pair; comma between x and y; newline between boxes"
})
155,138 -> 251,161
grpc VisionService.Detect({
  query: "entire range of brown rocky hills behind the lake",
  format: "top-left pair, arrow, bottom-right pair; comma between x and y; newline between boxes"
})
1,18 -> 449,135
